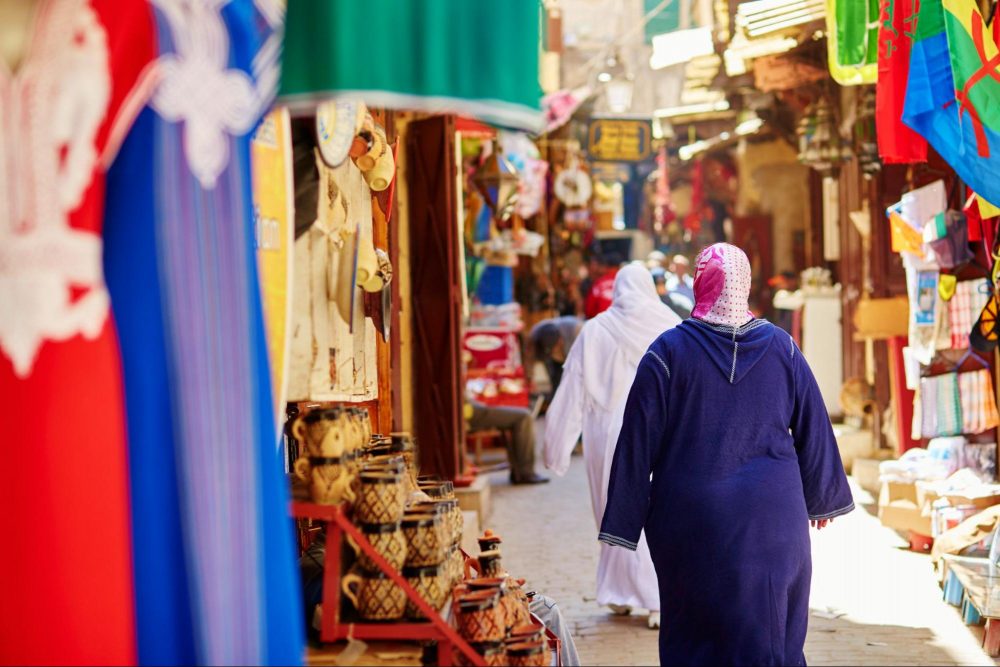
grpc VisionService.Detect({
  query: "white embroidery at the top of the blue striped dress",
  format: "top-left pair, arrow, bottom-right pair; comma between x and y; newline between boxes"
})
153,0 -> 260,189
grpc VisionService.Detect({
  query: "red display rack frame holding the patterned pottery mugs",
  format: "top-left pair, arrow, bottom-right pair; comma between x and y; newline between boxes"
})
291,502 -> 484,667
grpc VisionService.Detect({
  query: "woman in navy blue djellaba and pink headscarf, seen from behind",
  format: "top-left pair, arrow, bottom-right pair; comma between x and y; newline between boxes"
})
599,243 -> 854,665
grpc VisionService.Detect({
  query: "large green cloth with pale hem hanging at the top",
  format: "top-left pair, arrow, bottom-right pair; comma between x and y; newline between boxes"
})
279,0 -> 543,132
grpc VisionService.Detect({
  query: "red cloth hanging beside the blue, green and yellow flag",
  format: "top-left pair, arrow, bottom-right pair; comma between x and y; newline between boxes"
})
875,0 -> 927,164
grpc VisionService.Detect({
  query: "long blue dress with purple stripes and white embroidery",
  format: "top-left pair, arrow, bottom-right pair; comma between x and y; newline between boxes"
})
104,0 -> 304,664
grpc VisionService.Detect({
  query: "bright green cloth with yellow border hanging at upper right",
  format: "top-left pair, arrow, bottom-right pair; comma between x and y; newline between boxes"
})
826,0 -> 879,86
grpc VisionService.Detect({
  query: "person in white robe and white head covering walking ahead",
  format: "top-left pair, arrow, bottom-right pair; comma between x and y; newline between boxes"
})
544,263 -> 681,628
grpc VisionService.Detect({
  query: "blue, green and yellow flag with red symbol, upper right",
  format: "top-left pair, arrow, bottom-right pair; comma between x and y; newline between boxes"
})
903,0 -> 1000,202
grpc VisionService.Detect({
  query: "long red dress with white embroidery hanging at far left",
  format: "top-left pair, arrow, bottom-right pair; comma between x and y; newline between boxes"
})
0,0 -> 155,664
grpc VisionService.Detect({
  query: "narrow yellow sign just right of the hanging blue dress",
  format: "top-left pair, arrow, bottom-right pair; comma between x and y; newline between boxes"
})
250,109 -> 295,434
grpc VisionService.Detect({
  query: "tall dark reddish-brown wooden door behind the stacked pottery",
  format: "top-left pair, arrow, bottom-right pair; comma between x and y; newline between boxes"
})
406,116 -> 465,479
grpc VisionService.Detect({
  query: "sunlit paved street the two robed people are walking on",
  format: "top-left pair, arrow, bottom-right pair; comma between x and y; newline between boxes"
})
491,434 -> 1000,665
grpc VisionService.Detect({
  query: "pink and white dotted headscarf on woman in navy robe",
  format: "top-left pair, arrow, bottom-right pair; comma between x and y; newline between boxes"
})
691,243 -> 753,327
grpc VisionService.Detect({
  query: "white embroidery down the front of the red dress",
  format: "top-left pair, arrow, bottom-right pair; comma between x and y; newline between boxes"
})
0,0 -> 111,378
